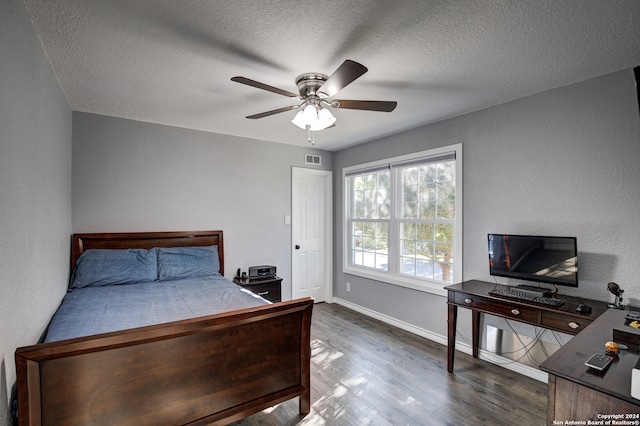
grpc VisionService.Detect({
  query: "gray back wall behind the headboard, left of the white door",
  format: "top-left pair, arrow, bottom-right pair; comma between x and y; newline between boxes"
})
72,112 -> 333,299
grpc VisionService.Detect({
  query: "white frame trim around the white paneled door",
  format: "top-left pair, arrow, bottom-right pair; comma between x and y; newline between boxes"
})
291,167 -> 333,303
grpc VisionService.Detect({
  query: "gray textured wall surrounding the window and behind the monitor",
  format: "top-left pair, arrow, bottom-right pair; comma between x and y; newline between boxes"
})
334,70 -> 640,346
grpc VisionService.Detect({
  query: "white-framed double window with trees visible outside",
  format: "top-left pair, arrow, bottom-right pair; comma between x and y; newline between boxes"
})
344,144 -> 462,293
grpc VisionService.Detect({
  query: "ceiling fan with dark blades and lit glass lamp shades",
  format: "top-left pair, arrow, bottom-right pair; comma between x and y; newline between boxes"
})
231,59 -> 398,140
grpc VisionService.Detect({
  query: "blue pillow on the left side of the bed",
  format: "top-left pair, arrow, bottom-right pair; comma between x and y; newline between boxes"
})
69,249 -> 158,288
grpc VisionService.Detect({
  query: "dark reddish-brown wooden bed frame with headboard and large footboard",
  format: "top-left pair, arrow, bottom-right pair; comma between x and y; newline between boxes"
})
16,231 -> 313,425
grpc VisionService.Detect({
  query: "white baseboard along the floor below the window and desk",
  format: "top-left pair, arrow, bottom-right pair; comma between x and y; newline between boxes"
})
331,297 -> 548,383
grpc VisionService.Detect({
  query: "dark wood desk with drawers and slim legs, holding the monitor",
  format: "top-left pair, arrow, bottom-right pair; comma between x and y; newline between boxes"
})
445,280 -> 608,374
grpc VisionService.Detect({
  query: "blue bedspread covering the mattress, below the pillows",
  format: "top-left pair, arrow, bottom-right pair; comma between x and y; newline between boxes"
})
45,275 -> 270,342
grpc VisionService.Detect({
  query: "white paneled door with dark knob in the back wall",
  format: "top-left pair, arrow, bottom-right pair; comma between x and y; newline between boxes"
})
291,167 -> 332,302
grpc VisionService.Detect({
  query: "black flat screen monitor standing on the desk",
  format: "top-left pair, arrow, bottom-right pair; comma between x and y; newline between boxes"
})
488,234 -> 578,287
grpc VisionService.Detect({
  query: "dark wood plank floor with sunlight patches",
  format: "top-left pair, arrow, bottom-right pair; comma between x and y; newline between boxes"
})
235,303 -> 547,426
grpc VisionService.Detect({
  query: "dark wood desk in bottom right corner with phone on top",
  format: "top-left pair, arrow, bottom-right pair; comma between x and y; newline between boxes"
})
540,309 -> 640,425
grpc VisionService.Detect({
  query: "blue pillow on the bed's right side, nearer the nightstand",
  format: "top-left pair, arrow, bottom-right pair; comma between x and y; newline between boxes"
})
158,245 -> 220,281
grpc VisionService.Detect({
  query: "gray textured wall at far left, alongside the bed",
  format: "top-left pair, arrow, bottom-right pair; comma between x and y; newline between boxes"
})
0,0 -> 71,424
